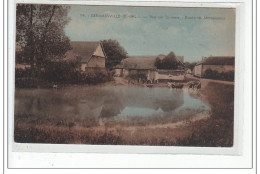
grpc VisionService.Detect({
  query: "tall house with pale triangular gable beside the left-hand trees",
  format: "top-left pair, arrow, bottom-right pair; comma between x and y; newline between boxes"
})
67,41 -> 107,72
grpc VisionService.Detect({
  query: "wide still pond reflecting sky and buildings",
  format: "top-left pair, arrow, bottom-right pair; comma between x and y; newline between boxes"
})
15,86 -> 210,127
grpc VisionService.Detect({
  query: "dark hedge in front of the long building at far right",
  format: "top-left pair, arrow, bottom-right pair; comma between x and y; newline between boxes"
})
204,69 -> 234,81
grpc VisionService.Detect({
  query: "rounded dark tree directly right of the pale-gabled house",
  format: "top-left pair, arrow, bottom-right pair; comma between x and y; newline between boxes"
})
101,39 -> 127,69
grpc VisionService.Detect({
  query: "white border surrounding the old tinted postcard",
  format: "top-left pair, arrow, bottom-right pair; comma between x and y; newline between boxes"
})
8,0 -> 252,168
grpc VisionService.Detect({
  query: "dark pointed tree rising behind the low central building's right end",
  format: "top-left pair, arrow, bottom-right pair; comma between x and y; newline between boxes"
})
154,52 -> 179,69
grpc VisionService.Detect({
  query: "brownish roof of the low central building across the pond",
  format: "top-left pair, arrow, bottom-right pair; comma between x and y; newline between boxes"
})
121,56 -> 157,69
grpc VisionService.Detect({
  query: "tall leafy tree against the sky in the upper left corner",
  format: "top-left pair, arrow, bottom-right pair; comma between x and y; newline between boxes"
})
16,4 -> 71,75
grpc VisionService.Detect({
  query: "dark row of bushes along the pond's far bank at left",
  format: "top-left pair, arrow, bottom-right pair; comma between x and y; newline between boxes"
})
15,61 -> 112,88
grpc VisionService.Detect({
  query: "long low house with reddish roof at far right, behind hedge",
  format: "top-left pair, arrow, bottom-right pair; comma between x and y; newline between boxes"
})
193,56 -> 235,77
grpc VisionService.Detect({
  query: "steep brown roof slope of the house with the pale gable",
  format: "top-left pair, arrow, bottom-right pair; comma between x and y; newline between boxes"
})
68,41 -> 100,62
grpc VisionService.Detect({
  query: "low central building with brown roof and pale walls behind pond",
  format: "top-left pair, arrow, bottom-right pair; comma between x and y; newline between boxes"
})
114,55 -> 185,81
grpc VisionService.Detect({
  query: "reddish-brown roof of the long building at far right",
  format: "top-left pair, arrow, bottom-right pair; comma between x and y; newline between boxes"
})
197,56 -> 235,65
